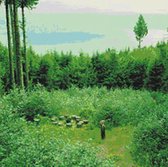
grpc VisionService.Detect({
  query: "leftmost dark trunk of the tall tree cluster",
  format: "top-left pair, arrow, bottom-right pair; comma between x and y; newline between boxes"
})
5,0 -> 15,88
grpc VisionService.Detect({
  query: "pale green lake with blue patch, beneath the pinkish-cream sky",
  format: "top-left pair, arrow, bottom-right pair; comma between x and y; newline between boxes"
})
0,11 -> 168,54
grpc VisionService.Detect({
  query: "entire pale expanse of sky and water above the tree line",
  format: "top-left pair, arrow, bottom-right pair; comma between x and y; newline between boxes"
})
0,0 -> 168,54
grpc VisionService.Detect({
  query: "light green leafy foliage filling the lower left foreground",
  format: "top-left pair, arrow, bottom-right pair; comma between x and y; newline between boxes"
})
0,102 -> 113,167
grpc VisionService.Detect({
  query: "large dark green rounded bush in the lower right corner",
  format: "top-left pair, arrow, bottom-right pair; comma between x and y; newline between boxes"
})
132,110 -> 168,167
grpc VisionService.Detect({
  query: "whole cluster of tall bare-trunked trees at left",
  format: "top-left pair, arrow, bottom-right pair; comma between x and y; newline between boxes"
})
0,0 -> 38,89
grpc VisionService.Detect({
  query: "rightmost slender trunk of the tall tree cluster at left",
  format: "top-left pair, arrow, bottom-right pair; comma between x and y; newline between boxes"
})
21,3 -> 29,88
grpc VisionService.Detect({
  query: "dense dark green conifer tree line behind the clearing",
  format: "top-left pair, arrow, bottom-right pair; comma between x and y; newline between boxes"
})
0,42 -> 168,92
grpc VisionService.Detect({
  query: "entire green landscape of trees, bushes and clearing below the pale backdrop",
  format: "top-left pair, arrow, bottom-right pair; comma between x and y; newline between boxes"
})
0,0 -> 168,167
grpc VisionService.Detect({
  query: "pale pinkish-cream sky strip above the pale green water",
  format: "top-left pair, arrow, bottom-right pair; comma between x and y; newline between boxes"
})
35,0 -> 168,14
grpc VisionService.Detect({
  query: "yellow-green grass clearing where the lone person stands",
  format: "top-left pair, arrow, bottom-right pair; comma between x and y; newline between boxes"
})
39,123 -> 134,167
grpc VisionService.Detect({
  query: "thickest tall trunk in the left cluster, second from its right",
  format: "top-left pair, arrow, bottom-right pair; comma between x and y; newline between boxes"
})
13,0 -> 24,89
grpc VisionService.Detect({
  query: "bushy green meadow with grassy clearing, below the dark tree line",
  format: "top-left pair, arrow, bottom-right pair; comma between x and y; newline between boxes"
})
0,85 -> 168,167
